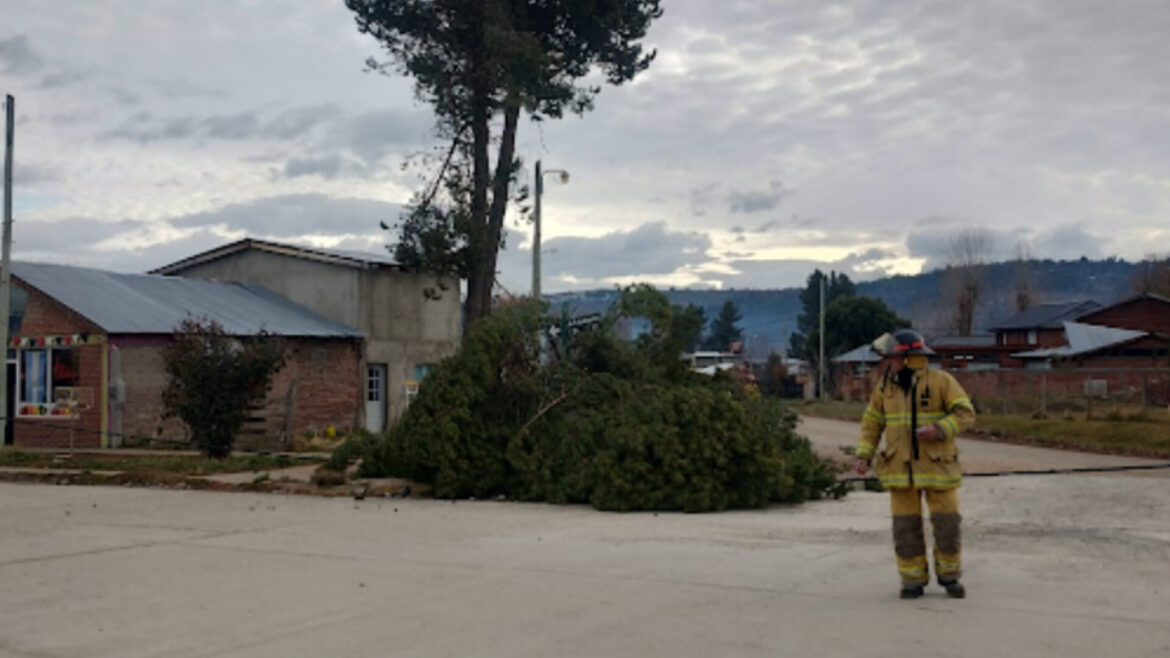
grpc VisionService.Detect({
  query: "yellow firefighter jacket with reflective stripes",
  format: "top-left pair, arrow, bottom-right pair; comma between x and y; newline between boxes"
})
856,369 -> 975,489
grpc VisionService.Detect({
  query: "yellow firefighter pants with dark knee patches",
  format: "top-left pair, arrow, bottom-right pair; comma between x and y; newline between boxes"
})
889,487 -> 962,585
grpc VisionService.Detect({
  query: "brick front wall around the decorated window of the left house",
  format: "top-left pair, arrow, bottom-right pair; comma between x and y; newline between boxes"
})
13,286 -> 103,447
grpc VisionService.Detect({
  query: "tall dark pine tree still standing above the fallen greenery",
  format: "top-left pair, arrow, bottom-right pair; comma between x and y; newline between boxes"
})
345,0 -> 662,324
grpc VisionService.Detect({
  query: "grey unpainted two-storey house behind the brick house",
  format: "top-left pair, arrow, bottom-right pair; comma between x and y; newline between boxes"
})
152,238 -> 462,432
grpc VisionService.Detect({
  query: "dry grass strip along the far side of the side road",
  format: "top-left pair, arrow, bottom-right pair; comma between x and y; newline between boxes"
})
791,400 -> 1170,459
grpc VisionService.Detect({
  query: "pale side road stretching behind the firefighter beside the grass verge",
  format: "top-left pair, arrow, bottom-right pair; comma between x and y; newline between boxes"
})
797,417 -> 1170,478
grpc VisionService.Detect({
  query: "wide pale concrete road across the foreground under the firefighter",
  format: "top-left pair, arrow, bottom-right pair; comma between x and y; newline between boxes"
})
0,468 -> 1170,658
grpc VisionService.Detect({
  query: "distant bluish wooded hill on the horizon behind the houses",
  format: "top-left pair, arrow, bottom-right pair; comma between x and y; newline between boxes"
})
546,259 -> 1134,356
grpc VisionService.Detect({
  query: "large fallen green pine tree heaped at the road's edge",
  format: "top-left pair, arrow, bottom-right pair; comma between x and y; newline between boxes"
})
346,286 -> 841,512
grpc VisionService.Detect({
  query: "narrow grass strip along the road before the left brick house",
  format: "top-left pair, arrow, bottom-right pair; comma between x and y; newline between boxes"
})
0,450 -> 319,475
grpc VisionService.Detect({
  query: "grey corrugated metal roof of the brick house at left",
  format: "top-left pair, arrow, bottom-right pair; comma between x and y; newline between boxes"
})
12,262 -> 364,337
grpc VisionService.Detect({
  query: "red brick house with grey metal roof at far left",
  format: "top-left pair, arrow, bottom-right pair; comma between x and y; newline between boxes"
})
5,262 -> 365,447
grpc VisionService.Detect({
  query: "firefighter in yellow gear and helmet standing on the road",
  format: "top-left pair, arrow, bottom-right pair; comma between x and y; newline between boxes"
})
854,329 -> 975,598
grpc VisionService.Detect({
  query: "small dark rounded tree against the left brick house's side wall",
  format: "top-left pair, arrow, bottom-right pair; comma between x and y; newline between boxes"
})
163,318 -> 284,459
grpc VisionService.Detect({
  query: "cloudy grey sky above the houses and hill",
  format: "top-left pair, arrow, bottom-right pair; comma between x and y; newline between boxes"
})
0,0 -> 1170,292
